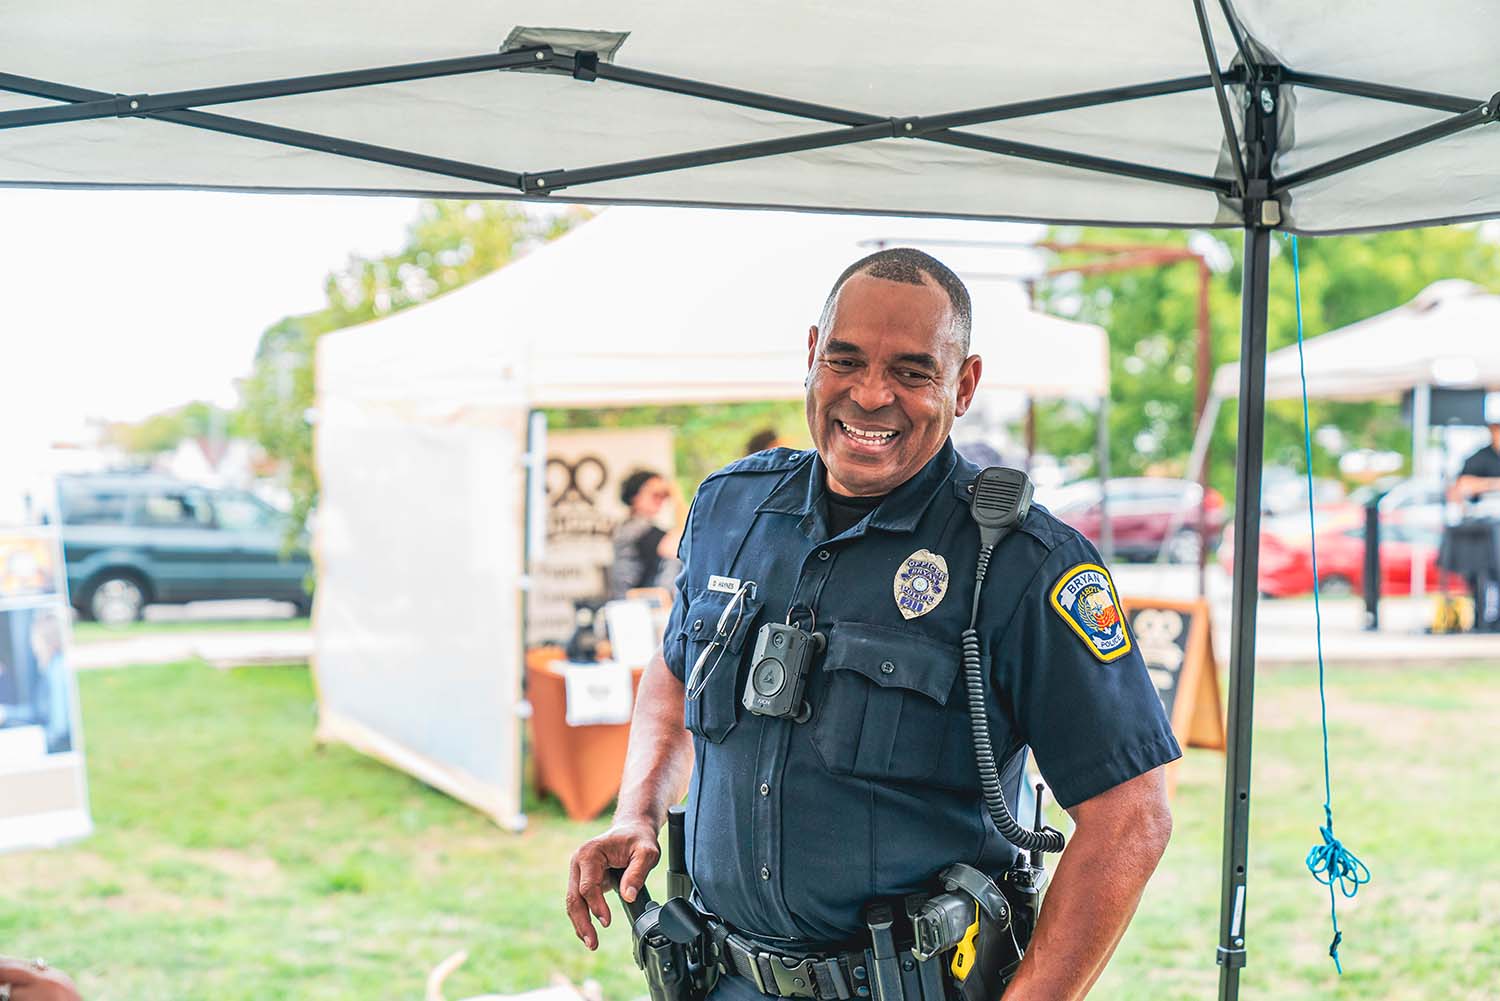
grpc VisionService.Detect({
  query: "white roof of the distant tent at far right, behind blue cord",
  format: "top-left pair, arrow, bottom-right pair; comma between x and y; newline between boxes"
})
1214,279 -> 1500,399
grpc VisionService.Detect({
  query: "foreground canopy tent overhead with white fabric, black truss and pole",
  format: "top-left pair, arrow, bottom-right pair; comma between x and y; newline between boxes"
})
0,0 -> 1500,998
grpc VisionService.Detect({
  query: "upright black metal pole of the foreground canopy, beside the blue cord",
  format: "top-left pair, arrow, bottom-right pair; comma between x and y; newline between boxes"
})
1217,66 -> 1281,1001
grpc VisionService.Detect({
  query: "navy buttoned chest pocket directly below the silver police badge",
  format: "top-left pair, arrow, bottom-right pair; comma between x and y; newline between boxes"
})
813,623 -> 972,785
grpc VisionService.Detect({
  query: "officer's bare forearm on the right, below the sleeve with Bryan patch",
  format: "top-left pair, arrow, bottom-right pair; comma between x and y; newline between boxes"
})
1005,768 -> 1172,1001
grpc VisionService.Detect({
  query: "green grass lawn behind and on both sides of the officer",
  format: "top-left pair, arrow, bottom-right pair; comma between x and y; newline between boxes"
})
0,663 -> 1500,1001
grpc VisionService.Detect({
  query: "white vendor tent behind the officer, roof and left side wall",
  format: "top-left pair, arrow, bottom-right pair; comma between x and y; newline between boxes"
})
317,207 -> 1109,825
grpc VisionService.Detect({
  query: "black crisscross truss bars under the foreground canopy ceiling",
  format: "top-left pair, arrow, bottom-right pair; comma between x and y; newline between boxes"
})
0,38 -> 1500,225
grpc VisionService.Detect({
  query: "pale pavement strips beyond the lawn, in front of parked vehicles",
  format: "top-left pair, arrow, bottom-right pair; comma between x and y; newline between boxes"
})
74,579 -> 1500,669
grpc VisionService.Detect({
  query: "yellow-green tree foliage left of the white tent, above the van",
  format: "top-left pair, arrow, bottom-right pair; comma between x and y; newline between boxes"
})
242,201 -> 588,528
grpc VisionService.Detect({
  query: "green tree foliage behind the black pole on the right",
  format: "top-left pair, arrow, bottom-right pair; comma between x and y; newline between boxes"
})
1038,227 -> 1500,492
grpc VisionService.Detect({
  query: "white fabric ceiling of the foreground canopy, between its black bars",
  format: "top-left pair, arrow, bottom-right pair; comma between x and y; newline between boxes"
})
0,0 -> 1500,233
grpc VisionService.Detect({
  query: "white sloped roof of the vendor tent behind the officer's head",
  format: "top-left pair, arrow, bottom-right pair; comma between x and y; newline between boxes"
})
318,207 -> 1109,407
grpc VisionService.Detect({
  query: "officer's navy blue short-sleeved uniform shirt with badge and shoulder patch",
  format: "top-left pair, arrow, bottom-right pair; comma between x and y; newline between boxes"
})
663,444 -> 1181,944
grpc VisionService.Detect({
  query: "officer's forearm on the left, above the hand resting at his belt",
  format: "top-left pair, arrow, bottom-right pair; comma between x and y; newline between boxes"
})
615,656 -> 693,828
